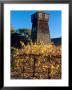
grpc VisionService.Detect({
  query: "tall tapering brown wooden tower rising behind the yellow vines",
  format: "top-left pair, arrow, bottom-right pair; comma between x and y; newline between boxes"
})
31,11 -> 51,44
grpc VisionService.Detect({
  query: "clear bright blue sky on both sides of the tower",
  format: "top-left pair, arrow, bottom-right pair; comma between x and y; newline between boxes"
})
10,10 -> 62,38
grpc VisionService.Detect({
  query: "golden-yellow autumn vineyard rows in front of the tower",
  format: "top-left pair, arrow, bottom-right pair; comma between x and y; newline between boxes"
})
11,41 -> 61,79
